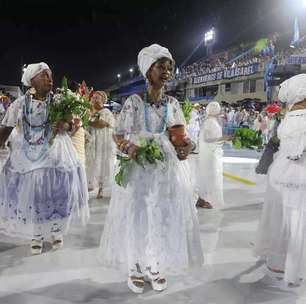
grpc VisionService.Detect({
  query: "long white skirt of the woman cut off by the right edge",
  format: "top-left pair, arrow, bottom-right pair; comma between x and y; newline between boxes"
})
255,155 -> 306,283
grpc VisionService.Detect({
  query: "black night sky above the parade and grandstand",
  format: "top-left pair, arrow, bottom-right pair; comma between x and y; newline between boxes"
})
0,0 -> 306,89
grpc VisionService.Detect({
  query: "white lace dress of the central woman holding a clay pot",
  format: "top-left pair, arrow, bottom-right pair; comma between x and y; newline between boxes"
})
99,95 -> 203,273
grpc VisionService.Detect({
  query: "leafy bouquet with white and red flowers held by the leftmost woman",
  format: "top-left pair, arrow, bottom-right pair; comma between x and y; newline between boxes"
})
48,77 -> 91,138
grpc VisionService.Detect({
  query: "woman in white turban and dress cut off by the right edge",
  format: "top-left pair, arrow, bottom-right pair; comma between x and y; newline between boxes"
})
256,74 -> 306,286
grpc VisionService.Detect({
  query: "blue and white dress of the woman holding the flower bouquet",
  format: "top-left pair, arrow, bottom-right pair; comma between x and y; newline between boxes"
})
0,94 -> 89,239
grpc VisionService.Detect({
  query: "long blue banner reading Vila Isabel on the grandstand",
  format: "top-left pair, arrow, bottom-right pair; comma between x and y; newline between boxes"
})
192,63 -> 259,84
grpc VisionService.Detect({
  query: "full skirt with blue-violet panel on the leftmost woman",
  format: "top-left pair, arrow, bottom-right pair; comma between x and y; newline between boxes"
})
0,135 -> 89,239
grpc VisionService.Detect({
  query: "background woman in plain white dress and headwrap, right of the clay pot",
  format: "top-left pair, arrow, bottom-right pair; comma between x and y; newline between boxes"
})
197,101 -> 224,209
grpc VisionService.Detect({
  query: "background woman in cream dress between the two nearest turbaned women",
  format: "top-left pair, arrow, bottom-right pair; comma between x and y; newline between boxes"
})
88,91 -> 116,198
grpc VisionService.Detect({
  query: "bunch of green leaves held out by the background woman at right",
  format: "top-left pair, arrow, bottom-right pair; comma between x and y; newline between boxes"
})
233,128 -> 262,149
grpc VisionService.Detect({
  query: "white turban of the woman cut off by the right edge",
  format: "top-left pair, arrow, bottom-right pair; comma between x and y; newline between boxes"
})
278,74 -> 306,105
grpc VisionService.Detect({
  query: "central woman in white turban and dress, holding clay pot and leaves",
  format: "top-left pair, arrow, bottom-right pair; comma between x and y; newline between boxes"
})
100,44 -> 203,293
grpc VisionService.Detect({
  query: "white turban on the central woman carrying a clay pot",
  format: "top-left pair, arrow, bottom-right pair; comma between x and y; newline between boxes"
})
138,44 -> 173,78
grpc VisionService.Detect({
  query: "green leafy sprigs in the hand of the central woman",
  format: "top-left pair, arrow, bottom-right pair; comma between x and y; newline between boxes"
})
115,139 -> 164,188
